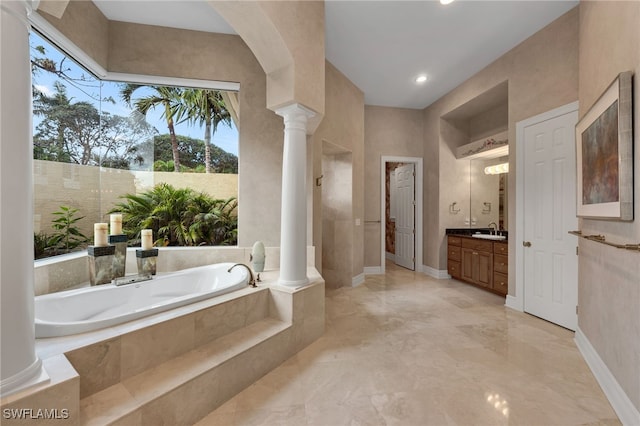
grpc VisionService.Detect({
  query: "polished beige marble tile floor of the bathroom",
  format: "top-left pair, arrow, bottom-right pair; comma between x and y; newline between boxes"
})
197,264 -> 620,426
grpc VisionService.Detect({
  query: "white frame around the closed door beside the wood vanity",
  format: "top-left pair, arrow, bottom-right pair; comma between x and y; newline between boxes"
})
505,101 -> 578,312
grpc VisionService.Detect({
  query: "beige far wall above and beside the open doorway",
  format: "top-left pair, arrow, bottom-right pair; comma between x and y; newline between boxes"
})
364,105 -> 424,266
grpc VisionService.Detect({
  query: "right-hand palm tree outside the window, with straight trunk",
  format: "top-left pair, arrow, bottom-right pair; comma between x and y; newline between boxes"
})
176,89 -> 231,173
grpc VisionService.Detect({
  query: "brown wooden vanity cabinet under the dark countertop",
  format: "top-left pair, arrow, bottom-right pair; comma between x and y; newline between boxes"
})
447,235 -> 509,295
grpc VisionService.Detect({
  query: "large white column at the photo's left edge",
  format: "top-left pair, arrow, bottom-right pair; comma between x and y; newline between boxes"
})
0,0 -> 46,396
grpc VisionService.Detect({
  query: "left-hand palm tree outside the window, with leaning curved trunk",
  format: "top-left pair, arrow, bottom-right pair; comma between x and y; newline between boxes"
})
120,83 -> 182,172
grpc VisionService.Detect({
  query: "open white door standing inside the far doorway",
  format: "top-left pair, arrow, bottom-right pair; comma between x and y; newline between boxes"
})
395,163 -> 416,271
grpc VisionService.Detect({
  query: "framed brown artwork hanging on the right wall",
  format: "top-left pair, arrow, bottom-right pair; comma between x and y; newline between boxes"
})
576,71 -> 633,221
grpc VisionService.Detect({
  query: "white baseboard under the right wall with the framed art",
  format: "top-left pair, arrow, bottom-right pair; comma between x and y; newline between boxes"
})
575,327 -> 640,425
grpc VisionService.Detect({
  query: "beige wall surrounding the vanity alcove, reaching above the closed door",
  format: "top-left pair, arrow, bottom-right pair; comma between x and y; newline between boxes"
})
424,8 -> 578,276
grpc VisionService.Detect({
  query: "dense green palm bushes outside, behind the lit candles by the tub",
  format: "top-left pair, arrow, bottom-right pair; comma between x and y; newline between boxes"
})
110,183 -> 238,246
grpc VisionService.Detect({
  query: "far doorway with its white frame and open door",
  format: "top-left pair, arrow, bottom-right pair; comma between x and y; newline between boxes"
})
380,156 -> 423,273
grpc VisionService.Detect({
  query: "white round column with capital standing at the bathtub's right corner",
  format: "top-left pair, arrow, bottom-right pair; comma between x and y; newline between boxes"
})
276,104 -> 315,287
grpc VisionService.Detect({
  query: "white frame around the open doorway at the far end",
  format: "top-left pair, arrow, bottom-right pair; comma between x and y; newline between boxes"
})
380,155 -> 423,274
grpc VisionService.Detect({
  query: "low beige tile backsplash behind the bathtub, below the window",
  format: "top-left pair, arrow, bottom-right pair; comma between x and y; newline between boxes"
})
34,246 -> 315,296
